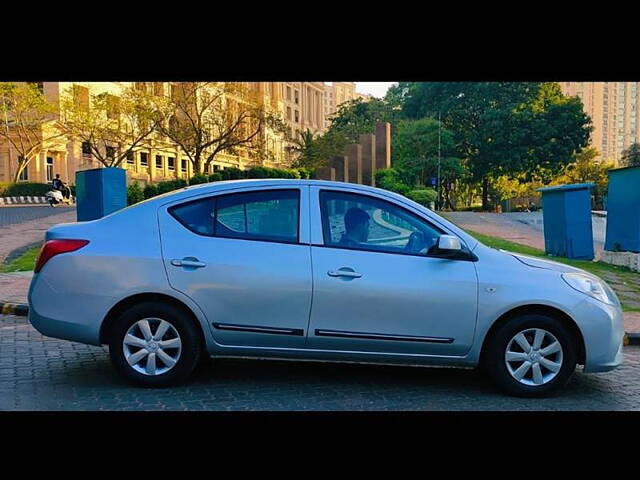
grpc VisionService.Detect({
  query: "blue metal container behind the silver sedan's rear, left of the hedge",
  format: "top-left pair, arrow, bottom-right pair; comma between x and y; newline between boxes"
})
76,167 -> 127,222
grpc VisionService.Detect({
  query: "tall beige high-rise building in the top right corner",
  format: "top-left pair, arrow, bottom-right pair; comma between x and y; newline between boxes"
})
560,82 -> 640,165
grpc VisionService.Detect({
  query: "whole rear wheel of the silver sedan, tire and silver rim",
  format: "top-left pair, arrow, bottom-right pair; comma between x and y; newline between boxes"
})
109,302 -> 202,387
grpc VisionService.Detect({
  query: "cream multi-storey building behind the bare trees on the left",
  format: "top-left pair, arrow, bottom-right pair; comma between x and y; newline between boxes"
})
0,82 -> 288,184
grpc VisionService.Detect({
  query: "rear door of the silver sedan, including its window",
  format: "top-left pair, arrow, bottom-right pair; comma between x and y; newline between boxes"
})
159,186 -> 312,348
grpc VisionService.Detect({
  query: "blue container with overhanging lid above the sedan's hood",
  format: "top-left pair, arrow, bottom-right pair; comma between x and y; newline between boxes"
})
538,183 -> 594,260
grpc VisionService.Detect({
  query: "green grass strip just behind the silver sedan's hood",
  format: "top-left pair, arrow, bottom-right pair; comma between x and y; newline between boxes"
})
465,229 -> 640,312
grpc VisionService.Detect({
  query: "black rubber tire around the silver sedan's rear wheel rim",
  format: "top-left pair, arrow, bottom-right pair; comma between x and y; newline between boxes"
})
109,302 -> 206,387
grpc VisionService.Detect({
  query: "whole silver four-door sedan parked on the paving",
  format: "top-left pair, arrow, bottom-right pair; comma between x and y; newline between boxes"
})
29,180 -> 623,396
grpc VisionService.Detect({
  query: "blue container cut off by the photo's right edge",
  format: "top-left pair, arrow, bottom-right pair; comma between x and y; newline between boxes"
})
604,167 -> 640,252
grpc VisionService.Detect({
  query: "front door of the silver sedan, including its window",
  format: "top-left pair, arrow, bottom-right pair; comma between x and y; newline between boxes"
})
307,186 -> 478,356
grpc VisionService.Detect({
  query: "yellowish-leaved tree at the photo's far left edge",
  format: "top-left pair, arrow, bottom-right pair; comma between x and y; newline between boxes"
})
0,82 -> 64,183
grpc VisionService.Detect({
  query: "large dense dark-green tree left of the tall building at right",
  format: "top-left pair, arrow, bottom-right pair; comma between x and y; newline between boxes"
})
394,82 -> 591,209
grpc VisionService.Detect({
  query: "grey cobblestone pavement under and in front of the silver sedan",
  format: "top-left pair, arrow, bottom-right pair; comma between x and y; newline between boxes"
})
0,316 -> 640,411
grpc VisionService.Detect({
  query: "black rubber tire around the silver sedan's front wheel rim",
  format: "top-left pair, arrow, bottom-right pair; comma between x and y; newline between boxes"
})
482,314 -> 577,398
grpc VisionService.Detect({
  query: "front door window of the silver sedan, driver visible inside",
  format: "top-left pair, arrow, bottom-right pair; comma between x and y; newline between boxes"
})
320,191 -> 444,255
